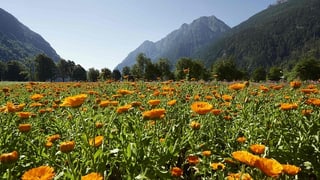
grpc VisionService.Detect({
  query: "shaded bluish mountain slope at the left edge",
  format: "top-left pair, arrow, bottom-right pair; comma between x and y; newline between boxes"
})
0,8 -> 60,61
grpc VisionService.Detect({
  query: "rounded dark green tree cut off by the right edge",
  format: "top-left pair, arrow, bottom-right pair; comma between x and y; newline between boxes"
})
293,57 -> 320,80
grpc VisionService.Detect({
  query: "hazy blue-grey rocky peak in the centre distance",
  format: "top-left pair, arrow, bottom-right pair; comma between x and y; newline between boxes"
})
116,16 -> 230,70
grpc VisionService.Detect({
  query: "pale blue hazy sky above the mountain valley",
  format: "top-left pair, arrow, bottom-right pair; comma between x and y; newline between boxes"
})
0,0 -> 275,70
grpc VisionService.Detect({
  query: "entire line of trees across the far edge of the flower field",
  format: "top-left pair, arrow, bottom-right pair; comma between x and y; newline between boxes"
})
0,53 -> 320,82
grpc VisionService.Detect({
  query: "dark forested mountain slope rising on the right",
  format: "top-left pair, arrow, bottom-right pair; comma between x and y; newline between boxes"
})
198,0 -> 320,72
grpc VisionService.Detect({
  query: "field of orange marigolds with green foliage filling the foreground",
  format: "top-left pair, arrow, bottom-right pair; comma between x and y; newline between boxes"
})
0,81 -> 320,180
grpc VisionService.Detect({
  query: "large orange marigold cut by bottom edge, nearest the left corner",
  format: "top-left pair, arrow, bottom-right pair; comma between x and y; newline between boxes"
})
21,166 -> 55,180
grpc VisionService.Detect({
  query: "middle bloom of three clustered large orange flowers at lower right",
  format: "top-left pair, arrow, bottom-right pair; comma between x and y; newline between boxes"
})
254,158 -> 283,177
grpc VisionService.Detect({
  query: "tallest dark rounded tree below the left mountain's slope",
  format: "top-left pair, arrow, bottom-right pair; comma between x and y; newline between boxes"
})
35,54 -> 57,81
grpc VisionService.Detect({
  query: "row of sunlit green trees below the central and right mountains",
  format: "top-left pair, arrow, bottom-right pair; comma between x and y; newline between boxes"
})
122,54 -> 320,81
